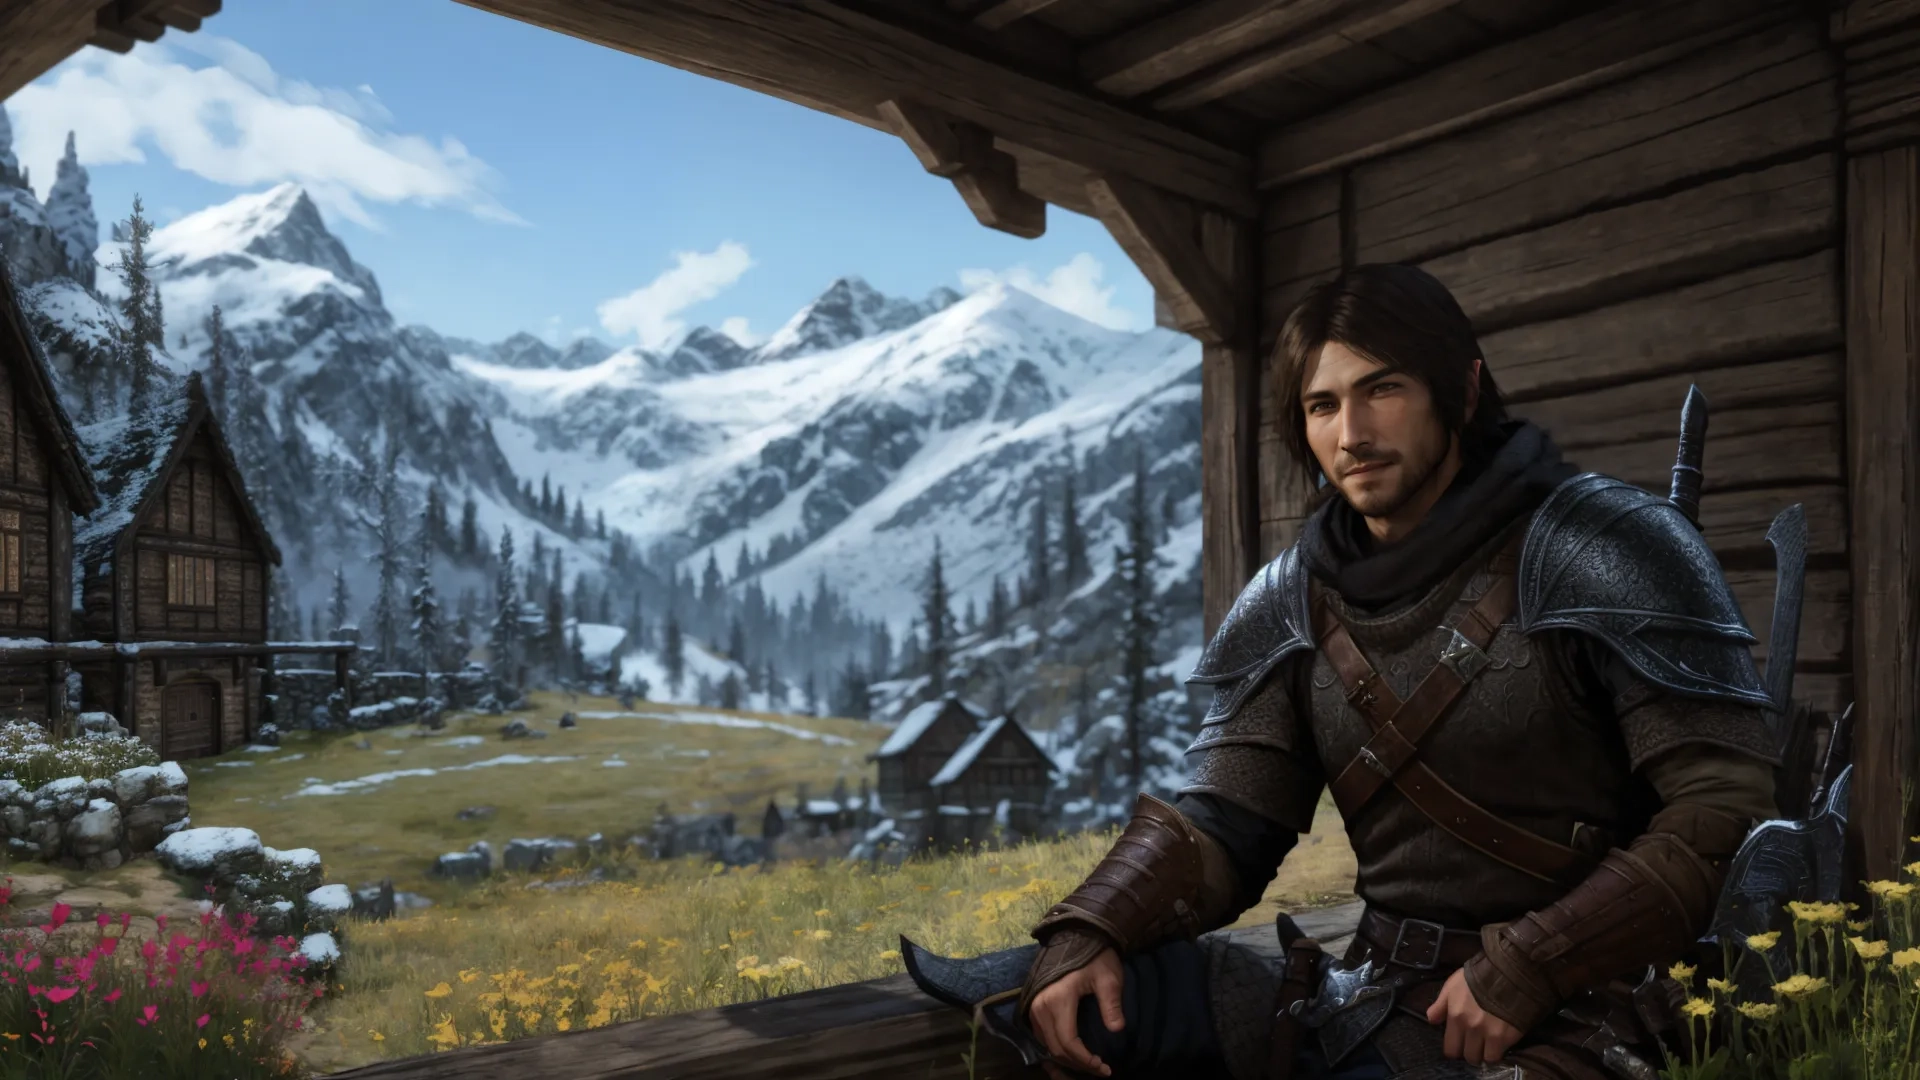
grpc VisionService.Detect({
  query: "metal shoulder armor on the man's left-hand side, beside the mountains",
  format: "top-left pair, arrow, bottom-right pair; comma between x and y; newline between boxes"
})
1187,546 -> 1313,719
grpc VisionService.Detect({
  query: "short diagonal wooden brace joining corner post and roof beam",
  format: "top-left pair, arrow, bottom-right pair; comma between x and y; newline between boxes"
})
1087,177 -> 1240,344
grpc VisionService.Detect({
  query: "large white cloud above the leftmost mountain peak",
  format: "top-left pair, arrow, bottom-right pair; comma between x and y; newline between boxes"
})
8,35 -> 524,227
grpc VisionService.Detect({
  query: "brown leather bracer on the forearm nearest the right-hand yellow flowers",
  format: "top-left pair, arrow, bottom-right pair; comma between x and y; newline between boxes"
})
1465,803 -> 1745,1032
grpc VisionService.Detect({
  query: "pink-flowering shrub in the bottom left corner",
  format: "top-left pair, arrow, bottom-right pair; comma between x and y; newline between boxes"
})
0,886 -> 321,1080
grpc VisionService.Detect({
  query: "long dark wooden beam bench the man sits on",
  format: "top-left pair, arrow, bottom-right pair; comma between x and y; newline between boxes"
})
318,901 -> 1361,1080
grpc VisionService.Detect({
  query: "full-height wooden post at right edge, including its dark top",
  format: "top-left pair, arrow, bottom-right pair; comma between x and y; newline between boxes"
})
1832,0 -> 1920,880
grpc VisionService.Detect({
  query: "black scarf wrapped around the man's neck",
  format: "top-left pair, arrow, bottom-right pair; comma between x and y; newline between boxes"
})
1300,421 -> 1578,611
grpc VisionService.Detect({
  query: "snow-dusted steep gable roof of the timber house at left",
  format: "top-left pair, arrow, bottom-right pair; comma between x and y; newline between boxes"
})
73,371 -> 280,580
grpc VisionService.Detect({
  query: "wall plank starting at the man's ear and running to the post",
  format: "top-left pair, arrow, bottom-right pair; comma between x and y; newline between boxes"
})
1480,252 -> 1841,404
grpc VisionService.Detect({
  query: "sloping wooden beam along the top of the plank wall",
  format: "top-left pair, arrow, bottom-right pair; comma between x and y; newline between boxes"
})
1256,0 -> 1791,188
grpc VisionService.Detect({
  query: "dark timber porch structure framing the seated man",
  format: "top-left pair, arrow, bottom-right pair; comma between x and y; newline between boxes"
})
0,0 -> 1920,1078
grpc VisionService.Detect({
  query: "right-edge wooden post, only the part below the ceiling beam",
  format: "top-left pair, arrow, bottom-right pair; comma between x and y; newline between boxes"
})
1847,146 -> 1920,878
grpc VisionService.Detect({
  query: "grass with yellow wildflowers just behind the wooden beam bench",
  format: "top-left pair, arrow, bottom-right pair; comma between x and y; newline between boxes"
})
298,787 -> 1354,1072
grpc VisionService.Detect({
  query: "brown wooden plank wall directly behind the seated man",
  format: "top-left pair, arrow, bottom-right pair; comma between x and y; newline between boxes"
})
1260,8 -> 1851,709
